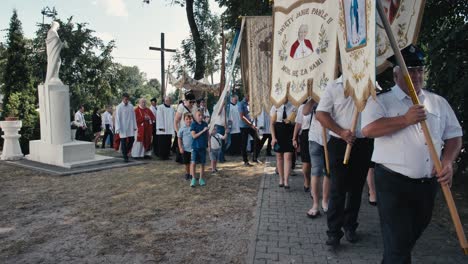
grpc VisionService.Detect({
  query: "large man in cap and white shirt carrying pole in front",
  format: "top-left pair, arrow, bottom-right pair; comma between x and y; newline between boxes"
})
362,45 -> 462,264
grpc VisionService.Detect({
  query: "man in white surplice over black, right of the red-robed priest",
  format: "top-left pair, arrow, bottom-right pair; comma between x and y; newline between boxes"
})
156,96 -> 175,160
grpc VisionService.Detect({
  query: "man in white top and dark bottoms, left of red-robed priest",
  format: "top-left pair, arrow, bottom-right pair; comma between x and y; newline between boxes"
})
115,93 -> 138,162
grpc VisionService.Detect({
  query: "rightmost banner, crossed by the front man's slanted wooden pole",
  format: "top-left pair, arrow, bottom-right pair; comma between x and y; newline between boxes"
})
376,0 -> 426,73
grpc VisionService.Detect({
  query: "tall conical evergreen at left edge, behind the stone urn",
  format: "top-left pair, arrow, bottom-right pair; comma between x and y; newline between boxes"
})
2,10 -> 39,153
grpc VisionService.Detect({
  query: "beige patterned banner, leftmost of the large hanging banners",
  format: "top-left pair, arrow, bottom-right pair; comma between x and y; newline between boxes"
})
241,16 -> 273,117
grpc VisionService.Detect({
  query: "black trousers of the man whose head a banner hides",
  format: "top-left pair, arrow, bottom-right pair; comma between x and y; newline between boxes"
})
327,137 -> 372,237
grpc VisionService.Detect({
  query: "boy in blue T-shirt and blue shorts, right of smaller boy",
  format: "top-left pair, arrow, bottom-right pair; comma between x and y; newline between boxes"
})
190,111 -> 208,187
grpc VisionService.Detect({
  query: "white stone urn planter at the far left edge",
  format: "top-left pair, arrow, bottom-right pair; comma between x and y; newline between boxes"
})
0,121 -> 24,160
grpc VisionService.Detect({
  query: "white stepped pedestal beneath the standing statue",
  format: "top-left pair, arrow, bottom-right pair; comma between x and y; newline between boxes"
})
26,84 -> 113,168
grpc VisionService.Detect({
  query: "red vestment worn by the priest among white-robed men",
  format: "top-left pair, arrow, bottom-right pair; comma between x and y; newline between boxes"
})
135,106 -> 156,151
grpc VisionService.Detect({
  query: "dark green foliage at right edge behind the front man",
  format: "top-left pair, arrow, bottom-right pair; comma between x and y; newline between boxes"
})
420,0 -> 468,176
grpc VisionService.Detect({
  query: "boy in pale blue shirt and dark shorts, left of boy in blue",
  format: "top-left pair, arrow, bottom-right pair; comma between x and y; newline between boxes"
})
177,112 -> 193,180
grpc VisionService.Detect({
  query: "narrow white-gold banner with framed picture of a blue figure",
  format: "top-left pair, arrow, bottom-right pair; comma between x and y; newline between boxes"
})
337,0 -> 376,112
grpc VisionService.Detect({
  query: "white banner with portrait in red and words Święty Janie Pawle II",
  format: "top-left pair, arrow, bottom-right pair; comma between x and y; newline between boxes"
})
270,0 -> 338,107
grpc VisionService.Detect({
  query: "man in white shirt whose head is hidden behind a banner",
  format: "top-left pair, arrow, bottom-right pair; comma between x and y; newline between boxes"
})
316,73 -> 372,246
